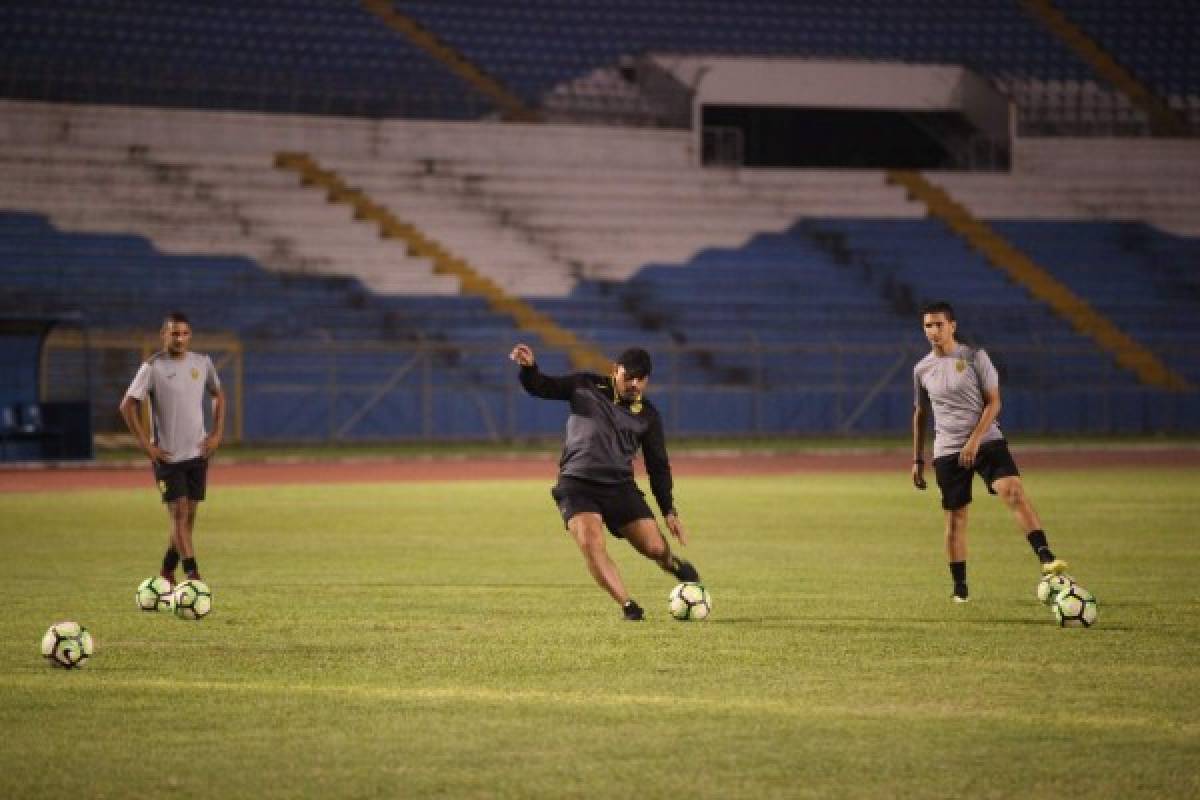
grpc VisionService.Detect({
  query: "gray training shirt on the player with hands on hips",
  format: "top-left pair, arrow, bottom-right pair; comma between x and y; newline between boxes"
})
125,351 -> 221,464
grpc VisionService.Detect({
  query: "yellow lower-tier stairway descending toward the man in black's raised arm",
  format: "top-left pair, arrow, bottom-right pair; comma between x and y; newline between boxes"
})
276,152 -> 610,372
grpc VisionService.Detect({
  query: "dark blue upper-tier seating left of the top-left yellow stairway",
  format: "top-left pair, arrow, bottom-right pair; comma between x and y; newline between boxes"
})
0,0 -> 491,119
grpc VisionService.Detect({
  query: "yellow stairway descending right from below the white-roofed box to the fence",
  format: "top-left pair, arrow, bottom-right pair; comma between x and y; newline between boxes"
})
888,170 -> 1190,391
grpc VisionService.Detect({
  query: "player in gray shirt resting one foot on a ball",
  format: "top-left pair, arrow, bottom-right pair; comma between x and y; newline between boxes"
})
912,302 -> 1067,603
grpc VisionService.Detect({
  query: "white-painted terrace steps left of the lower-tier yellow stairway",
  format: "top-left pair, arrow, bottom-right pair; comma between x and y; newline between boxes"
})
0,145 -> 458,294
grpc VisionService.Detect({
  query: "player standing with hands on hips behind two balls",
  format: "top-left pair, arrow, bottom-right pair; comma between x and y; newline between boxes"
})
120,312 -> 226,585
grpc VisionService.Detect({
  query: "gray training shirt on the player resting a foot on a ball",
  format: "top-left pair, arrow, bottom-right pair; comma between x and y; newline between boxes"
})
912,344 -> 1004,458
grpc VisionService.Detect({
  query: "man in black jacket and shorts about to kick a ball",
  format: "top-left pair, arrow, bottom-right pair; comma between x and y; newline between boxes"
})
509,344 -> 700,621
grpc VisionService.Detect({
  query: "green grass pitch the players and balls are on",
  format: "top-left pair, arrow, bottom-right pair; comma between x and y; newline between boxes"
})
0,469 -> 1200,799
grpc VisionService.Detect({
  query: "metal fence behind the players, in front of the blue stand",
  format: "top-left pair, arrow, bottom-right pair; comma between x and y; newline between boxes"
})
43,337 -> 1200,444
